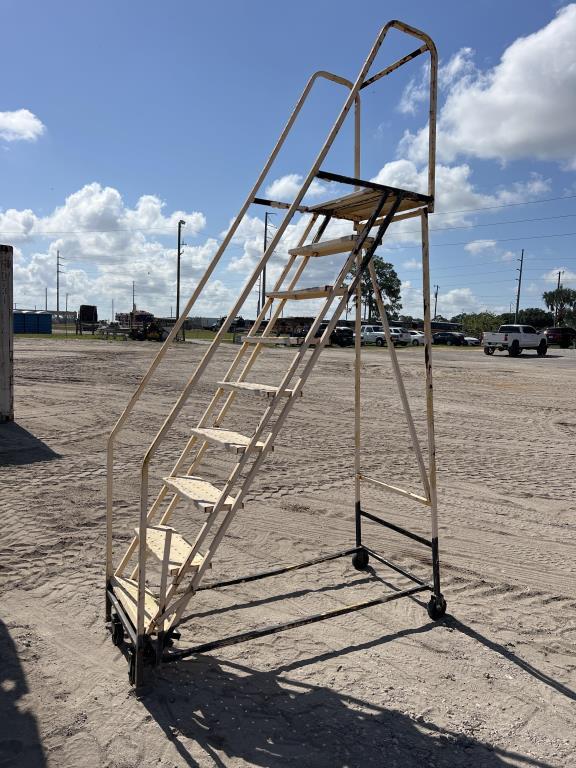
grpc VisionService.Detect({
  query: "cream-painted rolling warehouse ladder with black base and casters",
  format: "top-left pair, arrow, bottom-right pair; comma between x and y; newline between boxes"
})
106,21 -> 446,686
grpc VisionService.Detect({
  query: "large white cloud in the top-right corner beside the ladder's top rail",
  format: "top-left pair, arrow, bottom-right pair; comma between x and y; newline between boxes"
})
401,3 -> 576,169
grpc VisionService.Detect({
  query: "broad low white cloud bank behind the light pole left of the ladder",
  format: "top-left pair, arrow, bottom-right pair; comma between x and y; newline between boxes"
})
10,183 -> 218,317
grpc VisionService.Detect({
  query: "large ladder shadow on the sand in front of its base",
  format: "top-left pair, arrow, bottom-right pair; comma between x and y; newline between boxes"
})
142,636 -> 548,768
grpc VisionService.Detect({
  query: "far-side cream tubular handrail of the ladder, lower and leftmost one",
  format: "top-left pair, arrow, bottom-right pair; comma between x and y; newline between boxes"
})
106,70 -> 360,583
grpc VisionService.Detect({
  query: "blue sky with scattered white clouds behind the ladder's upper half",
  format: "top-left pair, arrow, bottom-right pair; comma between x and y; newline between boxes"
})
0,0 -> 576,317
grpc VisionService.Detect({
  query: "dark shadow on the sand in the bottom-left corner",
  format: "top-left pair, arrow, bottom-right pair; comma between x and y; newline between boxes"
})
0,621 -> 46,768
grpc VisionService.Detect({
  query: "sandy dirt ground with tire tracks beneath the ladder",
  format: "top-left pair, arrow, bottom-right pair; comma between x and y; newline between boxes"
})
0,339 -> 576,768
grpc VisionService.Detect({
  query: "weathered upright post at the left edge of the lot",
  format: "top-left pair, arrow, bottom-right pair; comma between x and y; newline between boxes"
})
0,245 -> 14,422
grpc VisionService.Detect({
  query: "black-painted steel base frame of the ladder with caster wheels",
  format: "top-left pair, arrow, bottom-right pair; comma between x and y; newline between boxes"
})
107,504 -> 446,686
